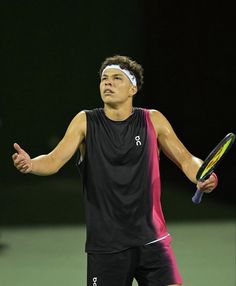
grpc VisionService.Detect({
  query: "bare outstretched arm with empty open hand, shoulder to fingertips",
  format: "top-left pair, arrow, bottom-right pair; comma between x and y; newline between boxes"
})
12,111 -> 86,176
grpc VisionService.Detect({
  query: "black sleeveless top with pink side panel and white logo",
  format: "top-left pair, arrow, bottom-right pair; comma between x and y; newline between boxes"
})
79,108 -> 167,253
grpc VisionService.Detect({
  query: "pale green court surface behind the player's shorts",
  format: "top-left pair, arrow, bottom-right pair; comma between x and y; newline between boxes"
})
0,222 -> 236,286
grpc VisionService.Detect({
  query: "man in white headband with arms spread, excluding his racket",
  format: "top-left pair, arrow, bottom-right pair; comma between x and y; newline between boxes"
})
13,56 -> 217,286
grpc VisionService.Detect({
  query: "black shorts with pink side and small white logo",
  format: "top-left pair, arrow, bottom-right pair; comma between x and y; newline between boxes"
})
87,236 -> 182,286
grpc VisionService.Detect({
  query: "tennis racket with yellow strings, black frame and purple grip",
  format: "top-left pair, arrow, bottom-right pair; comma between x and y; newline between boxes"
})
192,133 -> 235,204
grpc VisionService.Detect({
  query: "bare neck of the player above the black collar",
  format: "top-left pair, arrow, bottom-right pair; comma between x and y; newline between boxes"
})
104,105 -> 133,121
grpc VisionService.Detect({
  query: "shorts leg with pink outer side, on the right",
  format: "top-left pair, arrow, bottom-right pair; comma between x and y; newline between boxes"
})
135,237 -> 182,286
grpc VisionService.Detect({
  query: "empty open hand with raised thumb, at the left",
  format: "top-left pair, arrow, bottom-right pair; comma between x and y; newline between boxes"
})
12,143 -> 32,174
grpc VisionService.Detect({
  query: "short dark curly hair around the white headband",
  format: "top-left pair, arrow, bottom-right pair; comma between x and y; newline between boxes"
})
99,55 -> 143,90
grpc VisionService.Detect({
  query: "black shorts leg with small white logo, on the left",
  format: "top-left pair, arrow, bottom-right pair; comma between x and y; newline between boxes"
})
87,249 -> 137,286
